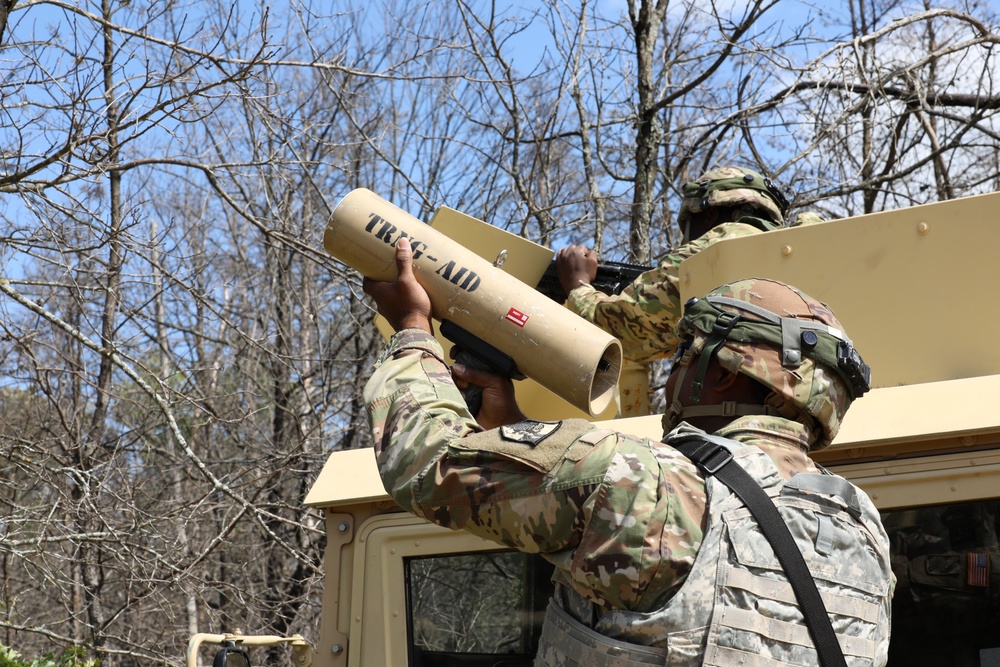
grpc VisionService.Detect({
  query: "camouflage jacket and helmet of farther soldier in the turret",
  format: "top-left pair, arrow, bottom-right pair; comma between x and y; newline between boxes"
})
566,167 -> 786,363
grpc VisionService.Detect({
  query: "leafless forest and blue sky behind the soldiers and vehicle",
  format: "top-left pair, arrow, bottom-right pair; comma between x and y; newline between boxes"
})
0,0 -> 1000,665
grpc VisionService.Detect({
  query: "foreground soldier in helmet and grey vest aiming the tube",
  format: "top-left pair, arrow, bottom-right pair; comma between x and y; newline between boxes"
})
365,240 -> 893,667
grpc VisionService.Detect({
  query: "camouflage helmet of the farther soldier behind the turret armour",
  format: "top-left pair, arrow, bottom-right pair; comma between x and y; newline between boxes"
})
677,167 -> 788,228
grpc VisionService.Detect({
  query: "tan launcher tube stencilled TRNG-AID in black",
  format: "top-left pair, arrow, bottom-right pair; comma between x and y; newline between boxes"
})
323,188 -> 622,416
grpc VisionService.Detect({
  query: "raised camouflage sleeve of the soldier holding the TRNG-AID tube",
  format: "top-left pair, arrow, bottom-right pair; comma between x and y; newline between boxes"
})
365,330 -> 614,553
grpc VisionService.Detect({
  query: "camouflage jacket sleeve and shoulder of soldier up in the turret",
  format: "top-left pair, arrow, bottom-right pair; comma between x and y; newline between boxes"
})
566,222 -> 762,363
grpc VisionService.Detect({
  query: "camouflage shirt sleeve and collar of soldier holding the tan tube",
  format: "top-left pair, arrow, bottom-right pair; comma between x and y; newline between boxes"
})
364,330 -> 828,616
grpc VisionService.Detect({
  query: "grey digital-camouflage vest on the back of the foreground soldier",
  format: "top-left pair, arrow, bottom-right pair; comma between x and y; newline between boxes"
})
535,443 -> 892,667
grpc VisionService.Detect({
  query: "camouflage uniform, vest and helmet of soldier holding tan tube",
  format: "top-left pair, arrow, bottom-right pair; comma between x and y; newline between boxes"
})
364,281 -> 892,667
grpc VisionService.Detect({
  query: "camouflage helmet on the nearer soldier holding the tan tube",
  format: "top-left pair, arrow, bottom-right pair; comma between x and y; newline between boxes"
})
664,278 -> 871,449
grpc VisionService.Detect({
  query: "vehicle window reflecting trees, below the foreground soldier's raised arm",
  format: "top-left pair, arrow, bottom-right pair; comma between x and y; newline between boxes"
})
406,551 -> 552,667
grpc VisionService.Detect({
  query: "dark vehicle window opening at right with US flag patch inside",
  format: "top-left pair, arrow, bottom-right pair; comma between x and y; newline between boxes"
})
882,500 -> 1000,667
